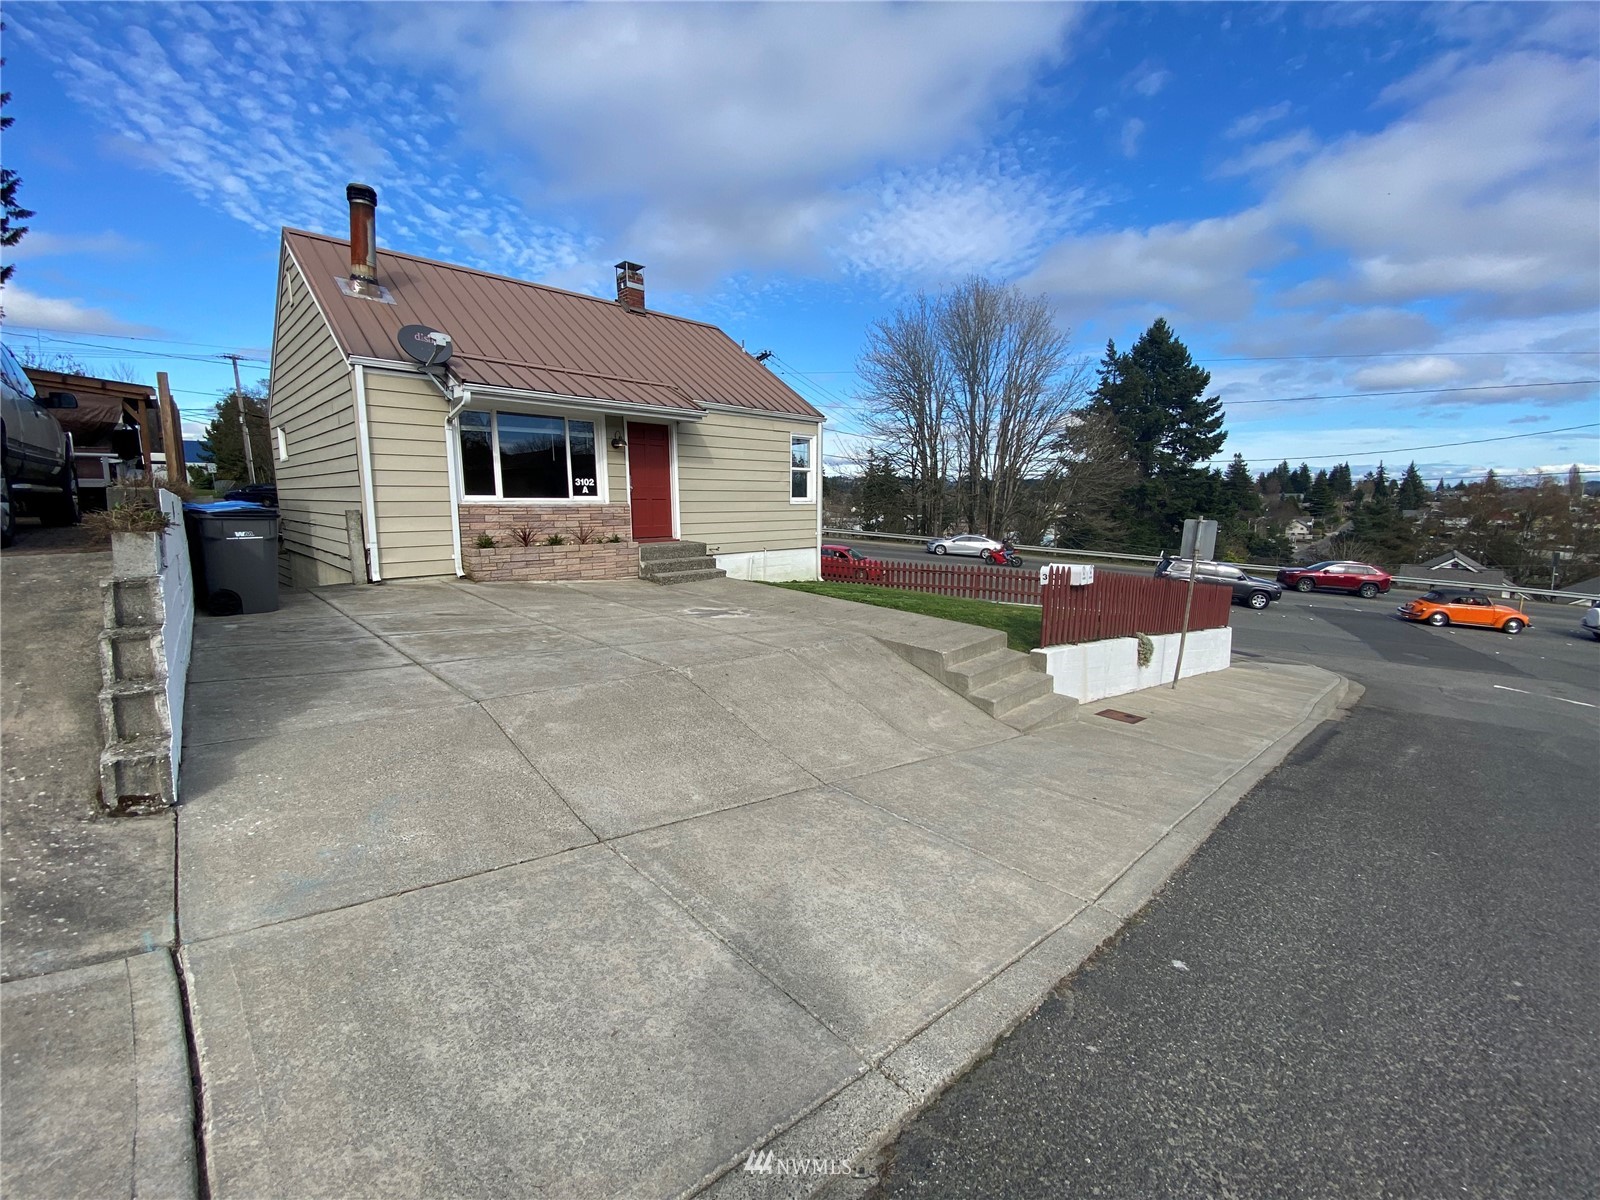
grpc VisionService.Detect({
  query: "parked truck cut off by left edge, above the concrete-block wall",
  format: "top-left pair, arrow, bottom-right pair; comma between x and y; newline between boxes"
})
0,344 -> 80,546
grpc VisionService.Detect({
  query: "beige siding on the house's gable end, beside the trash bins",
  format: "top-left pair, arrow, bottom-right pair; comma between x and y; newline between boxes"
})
269,253 -> 363,587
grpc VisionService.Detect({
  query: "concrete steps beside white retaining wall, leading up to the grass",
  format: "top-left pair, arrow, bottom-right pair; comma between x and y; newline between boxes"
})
878,629 -> 1077,733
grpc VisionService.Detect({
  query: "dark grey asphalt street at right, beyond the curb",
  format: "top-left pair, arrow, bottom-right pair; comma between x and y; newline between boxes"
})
874,595 -> 1600,1200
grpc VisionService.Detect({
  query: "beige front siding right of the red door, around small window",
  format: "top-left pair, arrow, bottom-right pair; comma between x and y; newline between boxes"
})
677,413 -> 821,554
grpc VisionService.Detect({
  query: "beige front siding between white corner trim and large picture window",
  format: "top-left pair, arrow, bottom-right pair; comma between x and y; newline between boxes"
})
366,370 -> 456,579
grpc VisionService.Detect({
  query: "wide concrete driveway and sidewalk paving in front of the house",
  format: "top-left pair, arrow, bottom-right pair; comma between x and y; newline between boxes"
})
178,581 -> 1344,1197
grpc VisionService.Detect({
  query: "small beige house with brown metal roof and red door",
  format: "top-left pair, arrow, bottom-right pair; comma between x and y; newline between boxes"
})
267,184 -> 824,587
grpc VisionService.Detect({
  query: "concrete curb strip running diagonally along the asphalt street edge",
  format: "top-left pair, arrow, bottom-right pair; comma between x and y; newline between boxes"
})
694,667 -> 1365,1200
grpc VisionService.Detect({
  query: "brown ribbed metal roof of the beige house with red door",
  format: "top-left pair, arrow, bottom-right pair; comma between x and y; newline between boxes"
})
283,229 -> 822,419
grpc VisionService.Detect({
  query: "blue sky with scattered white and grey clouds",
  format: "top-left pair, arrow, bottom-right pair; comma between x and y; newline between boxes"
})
3,2 -> 1600,480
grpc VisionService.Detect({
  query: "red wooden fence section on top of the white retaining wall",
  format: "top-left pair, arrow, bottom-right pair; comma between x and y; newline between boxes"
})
1038,571 -> 1234,646
